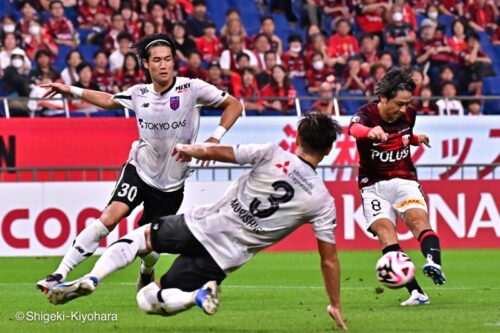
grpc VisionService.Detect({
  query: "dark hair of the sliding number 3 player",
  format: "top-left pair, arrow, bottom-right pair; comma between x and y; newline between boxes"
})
298,111 -> 342,154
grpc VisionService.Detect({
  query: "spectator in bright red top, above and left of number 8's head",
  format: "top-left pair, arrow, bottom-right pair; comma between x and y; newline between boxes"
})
328,18 -> 359,66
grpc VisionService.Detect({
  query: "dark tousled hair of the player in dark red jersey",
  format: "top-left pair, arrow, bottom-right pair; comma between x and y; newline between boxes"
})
375,67 -> 415,100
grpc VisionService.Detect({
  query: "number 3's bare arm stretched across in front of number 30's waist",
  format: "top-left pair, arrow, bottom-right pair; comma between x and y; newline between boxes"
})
172,143 -> 237,163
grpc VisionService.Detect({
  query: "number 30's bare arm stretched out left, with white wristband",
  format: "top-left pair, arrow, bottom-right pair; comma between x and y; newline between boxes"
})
40,83 -> 121,109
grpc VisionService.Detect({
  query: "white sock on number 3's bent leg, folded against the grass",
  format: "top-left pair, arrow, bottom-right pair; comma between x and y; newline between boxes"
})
137,282 -> 195,315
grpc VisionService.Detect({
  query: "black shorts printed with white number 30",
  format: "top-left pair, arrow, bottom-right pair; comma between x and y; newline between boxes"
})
108,163 -> 184,226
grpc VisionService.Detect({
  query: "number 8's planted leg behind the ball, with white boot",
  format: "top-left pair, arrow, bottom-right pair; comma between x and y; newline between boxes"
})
370,218 -> 430,306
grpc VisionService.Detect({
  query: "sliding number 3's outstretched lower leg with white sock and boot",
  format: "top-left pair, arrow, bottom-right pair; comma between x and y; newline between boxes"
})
47,224 -> 151,304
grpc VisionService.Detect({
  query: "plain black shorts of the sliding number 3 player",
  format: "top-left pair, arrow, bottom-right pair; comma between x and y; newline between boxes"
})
151,215 -> 226,291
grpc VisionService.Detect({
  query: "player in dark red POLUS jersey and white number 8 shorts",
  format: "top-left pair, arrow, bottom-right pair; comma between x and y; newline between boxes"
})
349,68 -> 445,306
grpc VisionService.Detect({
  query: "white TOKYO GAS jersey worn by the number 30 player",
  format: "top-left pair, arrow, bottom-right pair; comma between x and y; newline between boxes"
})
113,77 -> 228,192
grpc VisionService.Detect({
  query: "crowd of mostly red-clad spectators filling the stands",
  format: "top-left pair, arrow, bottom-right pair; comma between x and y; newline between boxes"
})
0,0 -> 500,115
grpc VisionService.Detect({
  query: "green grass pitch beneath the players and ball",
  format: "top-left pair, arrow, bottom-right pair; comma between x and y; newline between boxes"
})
0,250 -> 500,333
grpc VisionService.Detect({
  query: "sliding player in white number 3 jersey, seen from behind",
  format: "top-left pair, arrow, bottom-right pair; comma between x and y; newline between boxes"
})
47,113 -> 347,329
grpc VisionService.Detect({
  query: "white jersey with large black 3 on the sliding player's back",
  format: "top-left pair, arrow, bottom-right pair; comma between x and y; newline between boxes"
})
185,144 -> 335,272
